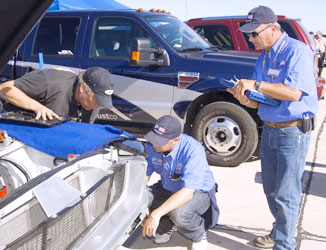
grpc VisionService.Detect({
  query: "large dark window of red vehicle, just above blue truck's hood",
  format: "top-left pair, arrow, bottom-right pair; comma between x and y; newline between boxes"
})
194,24 -> 234,50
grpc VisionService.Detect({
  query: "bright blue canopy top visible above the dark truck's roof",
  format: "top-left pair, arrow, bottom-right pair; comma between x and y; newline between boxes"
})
48,0 -> 130,11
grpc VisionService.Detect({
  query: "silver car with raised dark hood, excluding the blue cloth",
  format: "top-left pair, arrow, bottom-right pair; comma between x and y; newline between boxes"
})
0,0 -> 148,250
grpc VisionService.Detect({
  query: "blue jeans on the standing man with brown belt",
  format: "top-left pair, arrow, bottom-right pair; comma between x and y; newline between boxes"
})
260,125 -> 310,250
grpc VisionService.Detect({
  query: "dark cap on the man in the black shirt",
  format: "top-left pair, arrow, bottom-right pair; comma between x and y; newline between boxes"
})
83,67 -> 113,108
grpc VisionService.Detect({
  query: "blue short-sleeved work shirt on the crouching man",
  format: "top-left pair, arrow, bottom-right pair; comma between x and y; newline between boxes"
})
147,134 -> 216,192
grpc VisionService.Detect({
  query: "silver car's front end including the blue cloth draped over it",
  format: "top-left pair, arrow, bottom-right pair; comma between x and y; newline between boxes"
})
0,116 -> 148,250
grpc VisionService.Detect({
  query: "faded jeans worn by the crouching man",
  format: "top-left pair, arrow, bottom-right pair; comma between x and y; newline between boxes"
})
149,182 -> 210,242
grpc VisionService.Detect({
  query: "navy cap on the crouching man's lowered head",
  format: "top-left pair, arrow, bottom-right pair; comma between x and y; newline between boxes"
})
145,115 -> 182,147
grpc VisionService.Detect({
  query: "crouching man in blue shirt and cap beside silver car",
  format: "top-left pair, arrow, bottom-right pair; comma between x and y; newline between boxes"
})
142,115 -> 219,250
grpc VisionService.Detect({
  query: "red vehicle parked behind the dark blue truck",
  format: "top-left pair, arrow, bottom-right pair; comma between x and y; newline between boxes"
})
186,16 -> 325,99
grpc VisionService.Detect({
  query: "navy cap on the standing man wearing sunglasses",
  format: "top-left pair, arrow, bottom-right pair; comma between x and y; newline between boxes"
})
239,6 -> 277,33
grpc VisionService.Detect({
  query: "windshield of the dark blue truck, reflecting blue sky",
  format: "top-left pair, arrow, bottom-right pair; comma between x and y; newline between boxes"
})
146,16 -> 210,52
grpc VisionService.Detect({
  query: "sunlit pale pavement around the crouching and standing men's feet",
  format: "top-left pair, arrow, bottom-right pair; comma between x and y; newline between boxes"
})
118,83 -> 326,250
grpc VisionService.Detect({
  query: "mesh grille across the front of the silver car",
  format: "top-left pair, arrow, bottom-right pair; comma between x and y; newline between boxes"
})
0,166 -> 125,250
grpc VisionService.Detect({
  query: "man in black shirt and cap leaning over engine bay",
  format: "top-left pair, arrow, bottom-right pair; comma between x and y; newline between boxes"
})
0,67 -> 113,123
